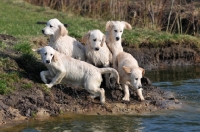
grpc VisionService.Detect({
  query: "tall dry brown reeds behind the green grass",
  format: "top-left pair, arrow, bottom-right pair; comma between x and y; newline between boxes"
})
26,0 -> 200,35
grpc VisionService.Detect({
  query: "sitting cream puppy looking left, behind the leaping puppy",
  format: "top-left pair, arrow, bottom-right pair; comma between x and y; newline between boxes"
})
42,18 -> 85,61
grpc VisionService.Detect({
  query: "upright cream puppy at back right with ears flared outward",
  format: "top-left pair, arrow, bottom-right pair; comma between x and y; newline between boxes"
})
106,21 -> 132,69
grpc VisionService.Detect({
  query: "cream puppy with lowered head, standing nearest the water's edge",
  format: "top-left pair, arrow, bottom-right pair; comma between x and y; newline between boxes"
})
116,52 -> 145,101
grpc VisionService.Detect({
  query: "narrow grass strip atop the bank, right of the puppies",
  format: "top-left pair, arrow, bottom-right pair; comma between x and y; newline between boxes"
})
123,28 -> 200,48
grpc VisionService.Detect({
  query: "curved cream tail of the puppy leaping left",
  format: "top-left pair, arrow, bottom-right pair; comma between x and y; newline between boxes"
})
99,67 -> 119,84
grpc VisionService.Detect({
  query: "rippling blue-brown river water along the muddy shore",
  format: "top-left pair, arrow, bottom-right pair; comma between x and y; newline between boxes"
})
0,66 -> 200,132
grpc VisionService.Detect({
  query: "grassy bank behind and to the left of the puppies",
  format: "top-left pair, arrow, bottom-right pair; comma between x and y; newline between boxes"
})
0,0 -> 200,94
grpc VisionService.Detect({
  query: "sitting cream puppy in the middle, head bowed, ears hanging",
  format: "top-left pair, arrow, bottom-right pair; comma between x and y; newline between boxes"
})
83,30 -> 112,88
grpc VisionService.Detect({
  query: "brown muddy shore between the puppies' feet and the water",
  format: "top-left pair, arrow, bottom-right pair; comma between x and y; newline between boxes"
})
0,81 -> 181,124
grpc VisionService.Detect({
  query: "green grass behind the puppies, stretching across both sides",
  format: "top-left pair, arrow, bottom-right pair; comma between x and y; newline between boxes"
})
0,0 -> 200,47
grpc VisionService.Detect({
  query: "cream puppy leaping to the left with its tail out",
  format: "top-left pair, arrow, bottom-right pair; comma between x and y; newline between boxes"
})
34,46 -> 119,103
